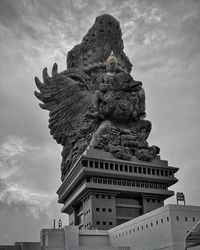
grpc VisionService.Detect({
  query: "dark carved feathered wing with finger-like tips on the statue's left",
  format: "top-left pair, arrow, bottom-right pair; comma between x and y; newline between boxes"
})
34,64 -> 92,146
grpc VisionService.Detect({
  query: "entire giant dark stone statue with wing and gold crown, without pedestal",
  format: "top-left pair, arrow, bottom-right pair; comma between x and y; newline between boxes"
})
35,15 -> 159,180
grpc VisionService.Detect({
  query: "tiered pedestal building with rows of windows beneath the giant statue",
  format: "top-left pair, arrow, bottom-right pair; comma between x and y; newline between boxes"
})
57,145 -> 178,230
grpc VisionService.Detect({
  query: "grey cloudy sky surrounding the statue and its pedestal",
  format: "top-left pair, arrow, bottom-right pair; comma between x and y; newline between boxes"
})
0,0 -> 200,244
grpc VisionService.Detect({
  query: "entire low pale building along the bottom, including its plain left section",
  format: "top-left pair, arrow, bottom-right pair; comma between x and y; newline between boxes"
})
41,205 -> 200,250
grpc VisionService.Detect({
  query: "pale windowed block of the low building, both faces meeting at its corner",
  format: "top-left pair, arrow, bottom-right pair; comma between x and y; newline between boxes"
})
109,205 -> 200,250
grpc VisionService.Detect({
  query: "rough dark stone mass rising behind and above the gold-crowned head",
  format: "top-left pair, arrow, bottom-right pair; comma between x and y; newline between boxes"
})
67,14 -> 132,73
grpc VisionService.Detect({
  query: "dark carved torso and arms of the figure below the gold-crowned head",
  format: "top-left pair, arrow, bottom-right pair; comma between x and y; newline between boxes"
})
95,72 -> 142,122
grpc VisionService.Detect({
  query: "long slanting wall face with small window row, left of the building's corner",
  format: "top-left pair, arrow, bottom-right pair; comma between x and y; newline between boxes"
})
109,205 -> 173,250
